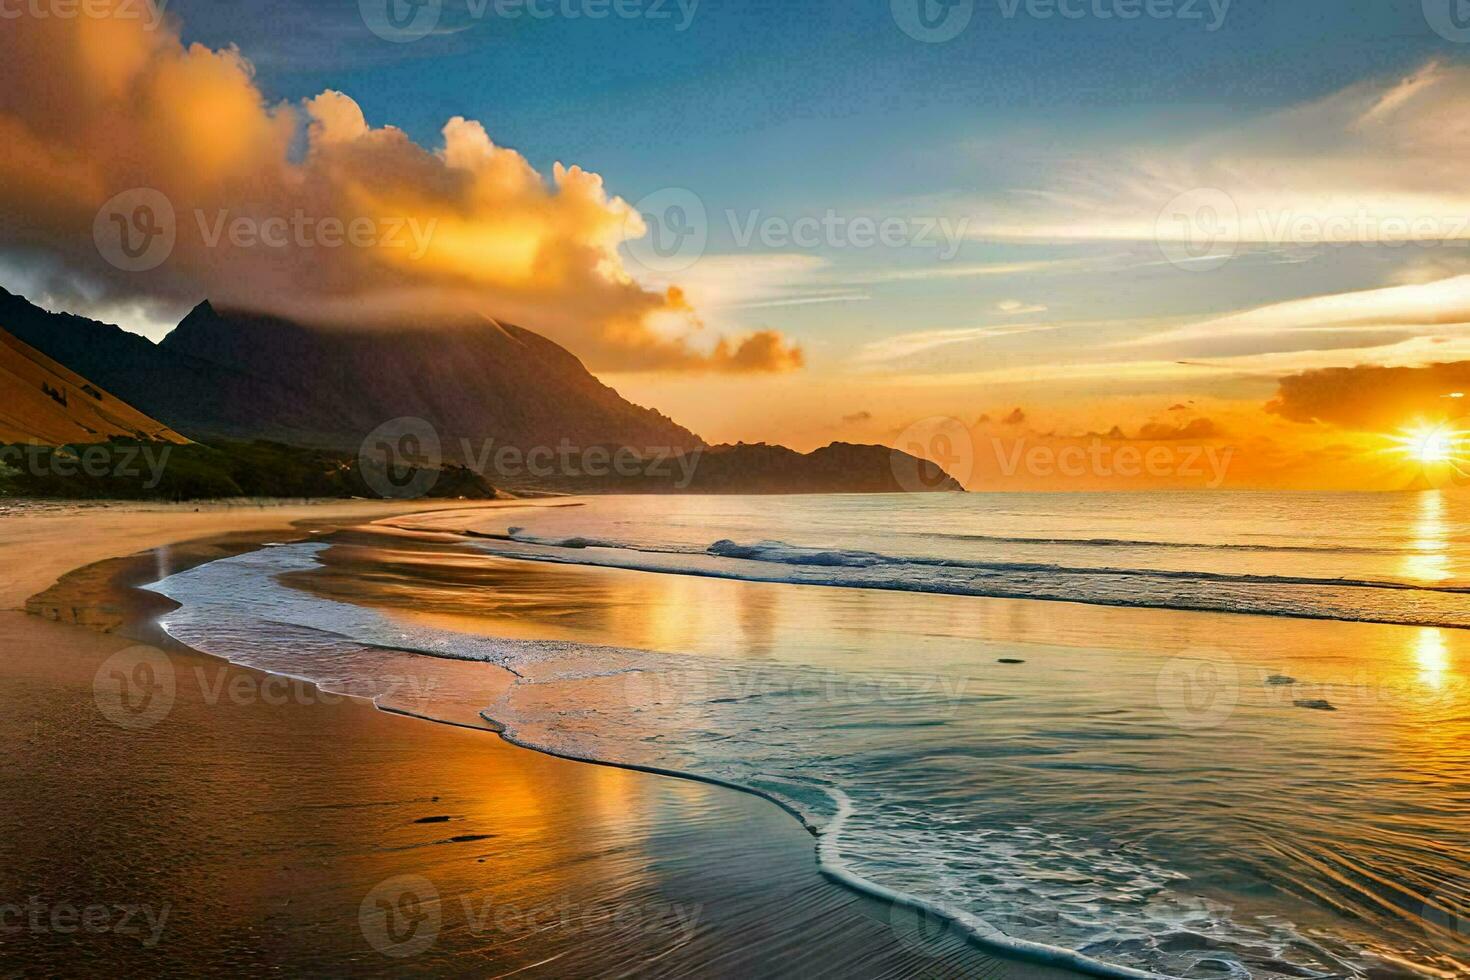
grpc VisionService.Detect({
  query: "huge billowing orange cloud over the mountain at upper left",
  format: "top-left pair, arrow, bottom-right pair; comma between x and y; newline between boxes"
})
0,0 -> 803,372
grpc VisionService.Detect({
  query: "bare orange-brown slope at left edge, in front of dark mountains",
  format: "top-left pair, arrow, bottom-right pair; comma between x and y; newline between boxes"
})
0,320 -> 187,445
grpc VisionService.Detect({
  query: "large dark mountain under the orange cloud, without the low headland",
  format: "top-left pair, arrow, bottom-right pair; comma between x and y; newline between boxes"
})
0,289 -> 704,458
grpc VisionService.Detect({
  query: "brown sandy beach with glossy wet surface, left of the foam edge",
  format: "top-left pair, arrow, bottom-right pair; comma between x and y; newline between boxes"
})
0,502 -> 1063,977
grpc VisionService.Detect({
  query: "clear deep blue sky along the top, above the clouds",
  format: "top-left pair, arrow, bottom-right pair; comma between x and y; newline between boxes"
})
171,0 -> 1446,185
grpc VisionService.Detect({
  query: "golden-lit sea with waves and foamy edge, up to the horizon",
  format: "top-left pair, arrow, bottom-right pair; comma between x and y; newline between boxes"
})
151,491 -> 1470,977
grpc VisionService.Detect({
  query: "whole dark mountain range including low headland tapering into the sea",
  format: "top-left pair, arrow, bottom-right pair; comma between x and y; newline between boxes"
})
0,289 -> 963,494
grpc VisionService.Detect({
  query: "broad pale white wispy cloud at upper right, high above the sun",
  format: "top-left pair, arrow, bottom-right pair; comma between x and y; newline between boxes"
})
969,63 -> 1470,248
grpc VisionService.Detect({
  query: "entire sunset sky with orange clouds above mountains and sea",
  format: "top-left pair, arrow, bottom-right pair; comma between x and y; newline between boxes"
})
0,0 -> 1470,489
